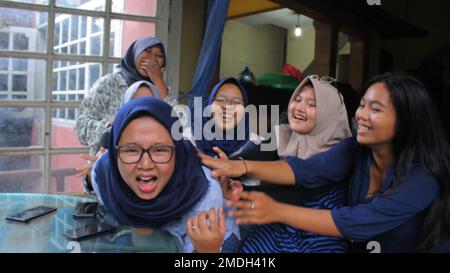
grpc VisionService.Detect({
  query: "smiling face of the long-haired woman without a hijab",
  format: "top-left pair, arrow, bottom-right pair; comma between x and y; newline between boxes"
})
355,83 -> 396,147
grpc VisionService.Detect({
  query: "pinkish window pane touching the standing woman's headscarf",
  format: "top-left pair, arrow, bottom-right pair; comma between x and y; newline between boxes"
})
109,20 -> 155,58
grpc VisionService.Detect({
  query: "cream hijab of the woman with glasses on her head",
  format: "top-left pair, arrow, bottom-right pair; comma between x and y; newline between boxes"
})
275,77 -> 351,159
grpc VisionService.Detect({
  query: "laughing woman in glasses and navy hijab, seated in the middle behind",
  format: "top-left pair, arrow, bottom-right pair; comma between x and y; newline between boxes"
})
186,77 -> 272,252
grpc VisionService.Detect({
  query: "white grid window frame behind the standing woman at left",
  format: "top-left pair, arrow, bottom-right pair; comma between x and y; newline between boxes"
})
0,0 -> 176,193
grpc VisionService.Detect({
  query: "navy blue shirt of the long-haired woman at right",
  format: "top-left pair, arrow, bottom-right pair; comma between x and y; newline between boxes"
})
286,137 -> 439,252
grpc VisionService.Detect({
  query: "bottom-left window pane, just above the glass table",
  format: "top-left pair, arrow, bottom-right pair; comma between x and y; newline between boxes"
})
0,154 -> 44,193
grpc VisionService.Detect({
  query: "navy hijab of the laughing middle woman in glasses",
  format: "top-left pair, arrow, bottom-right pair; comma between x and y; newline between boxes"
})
195,78 -> 250,156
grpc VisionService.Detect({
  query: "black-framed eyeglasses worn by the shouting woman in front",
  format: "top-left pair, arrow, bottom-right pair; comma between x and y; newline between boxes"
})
115,144 -> 175,164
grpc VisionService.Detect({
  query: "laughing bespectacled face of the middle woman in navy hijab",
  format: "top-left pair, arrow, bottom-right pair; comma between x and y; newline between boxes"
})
211,83 -> 245,130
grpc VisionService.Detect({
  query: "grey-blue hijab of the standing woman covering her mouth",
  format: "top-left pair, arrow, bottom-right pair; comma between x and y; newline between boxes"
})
117,37 -> 167,86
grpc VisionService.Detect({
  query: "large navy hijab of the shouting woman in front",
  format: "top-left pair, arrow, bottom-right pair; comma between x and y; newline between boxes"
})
94,97 -> 209,227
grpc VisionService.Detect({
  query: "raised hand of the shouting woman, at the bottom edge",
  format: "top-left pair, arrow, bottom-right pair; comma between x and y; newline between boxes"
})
186,208 -> 226,253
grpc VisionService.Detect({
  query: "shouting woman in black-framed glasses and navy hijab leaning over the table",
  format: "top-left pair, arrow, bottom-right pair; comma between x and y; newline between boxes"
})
92,97 -> 231,252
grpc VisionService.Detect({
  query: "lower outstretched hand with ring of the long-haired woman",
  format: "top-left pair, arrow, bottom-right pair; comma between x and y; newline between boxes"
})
227,191 -> 279,224
